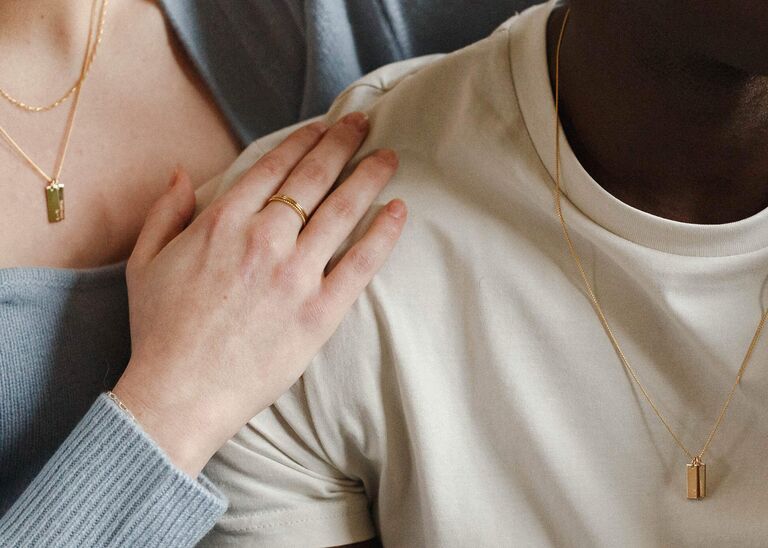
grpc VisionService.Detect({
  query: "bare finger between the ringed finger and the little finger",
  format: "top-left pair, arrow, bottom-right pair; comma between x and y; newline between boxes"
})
297,149 -> 397,266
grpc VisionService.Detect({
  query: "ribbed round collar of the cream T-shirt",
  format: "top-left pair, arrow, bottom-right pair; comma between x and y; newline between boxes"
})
509,0 -> 768,257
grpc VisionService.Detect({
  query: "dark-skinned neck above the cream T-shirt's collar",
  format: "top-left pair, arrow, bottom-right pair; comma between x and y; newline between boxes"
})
547,3 -> 768,224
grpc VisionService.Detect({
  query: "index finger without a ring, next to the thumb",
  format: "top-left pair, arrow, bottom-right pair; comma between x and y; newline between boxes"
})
213,122 -> 327,218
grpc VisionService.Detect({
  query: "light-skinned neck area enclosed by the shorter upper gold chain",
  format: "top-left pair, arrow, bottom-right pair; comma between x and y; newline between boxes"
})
0,0 -> 98,102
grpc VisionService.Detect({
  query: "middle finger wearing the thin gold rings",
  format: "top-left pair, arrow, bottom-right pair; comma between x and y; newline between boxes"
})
264,112 -> 368,237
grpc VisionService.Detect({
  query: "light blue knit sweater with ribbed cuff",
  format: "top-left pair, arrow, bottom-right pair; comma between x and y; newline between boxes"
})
0,0 -> 531,547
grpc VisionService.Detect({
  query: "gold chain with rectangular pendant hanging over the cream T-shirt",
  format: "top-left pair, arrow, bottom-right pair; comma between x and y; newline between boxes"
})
555,8 -> 768,499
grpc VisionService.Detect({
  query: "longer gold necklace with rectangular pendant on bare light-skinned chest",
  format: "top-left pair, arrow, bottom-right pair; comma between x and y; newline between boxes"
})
0,0 -> 109,223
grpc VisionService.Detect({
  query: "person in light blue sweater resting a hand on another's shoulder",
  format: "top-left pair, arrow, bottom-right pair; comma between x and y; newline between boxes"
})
0,0 -> 520,546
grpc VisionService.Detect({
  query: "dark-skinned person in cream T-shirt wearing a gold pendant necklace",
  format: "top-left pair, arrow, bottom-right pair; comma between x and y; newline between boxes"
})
202,0 -> 768,547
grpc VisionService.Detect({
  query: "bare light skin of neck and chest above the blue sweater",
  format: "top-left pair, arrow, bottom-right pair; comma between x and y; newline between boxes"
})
0,0 -> 239,268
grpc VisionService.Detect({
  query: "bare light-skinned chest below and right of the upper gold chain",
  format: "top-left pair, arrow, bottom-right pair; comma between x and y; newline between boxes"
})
0,3 -> 238,268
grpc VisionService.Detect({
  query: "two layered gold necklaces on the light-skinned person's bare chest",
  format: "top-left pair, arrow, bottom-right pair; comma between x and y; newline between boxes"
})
0,0 -> 109,223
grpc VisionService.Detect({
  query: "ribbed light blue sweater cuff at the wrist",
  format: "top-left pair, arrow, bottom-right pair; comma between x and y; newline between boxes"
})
0,395 -> 227,547
